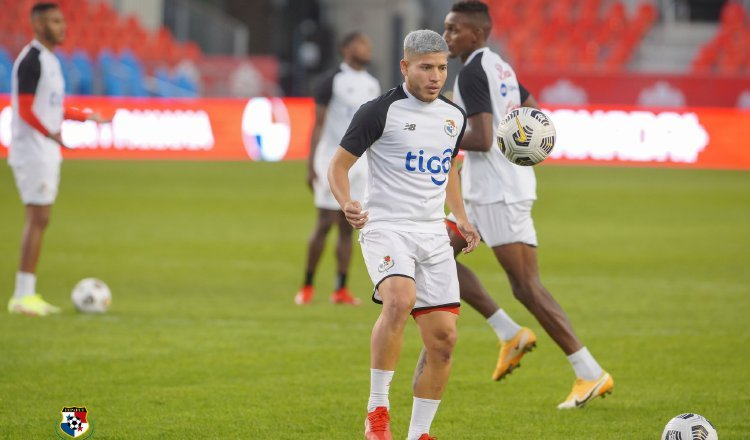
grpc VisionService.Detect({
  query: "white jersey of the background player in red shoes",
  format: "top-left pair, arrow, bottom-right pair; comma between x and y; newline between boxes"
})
315,63 -> 380,171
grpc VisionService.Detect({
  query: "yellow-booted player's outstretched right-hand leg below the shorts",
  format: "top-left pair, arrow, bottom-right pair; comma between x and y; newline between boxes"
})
493,243 -> 614,409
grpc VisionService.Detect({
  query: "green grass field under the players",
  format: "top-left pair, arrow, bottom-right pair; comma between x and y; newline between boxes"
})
0,161 -> 750,439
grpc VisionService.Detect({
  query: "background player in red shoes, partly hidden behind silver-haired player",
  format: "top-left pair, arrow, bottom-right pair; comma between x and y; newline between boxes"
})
294,32 -> 380,305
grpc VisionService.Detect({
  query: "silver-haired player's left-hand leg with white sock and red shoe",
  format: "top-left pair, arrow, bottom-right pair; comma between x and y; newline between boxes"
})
365,275 -> 416,440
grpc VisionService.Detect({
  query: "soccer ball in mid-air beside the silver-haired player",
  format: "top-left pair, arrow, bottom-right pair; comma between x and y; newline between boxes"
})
495,107 -> 556,166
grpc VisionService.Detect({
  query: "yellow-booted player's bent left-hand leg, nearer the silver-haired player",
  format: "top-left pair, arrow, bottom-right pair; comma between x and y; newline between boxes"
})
448,223 -> 536,380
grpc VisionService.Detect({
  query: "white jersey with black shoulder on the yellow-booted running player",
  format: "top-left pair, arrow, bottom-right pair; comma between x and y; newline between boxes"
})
453,47 -> 536,204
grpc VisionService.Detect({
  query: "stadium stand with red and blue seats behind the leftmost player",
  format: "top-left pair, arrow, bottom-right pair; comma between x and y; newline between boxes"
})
0,0 -> 203,97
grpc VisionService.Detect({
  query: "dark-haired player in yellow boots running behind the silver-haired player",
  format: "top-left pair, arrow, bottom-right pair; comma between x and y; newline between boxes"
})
443,1 -> 614,409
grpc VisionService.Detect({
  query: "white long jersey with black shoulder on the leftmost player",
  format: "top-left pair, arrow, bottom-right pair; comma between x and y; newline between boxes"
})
8,40 -> 65,166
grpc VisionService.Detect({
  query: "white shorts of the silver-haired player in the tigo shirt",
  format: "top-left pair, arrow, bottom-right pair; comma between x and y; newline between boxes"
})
359,229 -> 461,316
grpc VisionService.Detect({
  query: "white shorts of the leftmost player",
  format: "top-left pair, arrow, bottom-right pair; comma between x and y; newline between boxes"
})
11,162 -> 60,206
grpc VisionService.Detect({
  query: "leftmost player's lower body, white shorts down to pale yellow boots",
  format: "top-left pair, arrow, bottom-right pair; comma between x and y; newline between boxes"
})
8,164 -> 60,316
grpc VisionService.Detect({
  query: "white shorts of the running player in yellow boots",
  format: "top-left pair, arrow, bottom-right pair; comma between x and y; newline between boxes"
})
448,200 -> 538,248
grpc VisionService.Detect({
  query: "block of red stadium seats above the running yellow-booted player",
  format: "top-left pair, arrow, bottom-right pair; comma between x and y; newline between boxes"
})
489,0 -> 658,71
